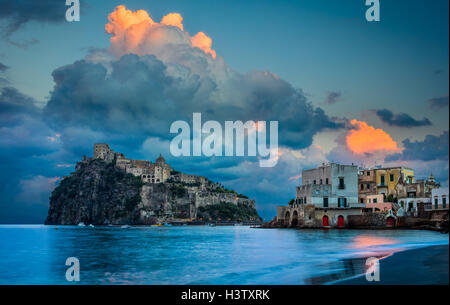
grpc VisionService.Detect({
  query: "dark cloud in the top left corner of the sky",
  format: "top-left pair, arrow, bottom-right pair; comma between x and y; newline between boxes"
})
0,0 -> 67,38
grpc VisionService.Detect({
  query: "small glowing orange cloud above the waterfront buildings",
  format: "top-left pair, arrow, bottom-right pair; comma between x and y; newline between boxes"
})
346,120 -> 399,154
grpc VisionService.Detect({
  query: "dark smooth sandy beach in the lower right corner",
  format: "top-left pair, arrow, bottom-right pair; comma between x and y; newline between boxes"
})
334,245 -> 449,285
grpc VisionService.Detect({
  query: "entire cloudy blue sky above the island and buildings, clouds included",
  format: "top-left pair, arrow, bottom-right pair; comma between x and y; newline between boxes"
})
0,0 -> 449,223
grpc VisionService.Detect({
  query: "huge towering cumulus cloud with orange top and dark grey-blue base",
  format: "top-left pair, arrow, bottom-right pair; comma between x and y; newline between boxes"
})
44,6 -> 343,148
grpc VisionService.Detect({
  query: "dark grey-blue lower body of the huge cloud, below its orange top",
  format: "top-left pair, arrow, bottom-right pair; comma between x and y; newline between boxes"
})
44,55 -> 342,148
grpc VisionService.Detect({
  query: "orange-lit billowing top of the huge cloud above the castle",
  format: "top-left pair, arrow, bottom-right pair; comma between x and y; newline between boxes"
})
105,5 -> 216,59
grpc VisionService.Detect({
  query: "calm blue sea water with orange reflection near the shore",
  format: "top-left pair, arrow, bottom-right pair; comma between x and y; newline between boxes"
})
0,225 -> 449,284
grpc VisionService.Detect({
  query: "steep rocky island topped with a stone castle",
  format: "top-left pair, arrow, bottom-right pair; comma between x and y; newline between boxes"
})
45,144 -> 261,225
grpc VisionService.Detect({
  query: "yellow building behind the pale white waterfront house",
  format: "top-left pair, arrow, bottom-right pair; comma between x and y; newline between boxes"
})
376,167 -> 415,197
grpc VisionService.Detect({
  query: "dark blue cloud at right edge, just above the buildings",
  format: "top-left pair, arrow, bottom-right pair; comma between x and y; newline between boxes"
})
386,131 -> 449,162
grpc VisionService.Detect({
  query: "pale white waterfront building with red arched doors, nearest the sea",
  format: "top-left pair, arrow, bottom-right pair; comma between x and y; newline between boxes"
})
277,163 -> 365,227
